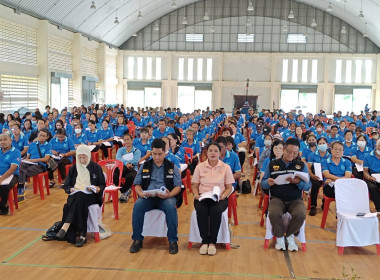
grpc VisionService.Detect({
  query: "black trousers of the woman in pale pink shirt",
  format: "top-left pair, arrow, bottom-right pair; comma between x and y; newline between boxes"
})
194,199 -> 228,244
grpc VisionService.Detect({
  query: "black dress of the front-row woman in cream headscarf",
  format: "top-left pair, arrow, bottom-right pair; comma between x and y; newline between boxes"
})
62,161 -> 106,243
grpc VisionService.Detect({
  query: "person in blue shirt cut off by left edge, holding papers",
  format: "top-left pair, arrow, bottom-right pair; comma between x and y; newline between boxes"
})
0,133 -> 21,215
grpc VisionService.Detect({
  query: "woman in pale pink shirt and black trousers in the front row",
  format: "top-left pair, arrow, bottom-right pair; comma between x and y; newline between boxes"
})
192,143 -> 235,255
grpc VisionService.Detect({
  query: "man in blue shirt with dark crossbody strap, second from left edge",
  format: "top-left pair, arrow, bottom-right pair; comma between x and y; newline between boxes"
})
18,128 -> 53,201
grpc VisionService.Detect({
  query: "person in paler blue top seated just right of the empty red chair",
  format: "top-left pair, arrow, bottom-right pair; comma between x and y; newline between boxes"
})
114,133 -> 141,203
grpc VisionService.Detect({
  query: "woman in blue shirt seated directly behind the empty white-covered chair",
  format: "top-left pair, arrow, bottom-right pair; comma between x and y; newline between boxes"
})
322,142 -> 352,201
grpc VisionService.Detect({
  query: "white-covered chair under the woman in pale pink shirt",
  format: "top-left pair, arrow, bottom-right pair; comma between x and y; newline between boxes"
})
187,209 -> 231,250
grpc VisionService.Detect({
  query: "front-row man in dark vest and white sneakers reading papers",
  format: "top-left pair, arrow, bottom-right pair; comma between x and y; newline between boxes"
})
261,138 -> 310,251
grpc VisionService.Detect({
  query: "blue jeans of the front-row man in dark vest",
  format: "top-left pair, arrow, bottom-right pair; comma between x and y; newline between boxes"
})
132,197 -> 178,242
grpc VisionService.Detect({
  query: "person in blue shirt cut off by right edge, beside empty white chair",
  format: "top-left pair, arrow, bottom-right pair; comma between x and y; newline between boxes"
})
363,140 -> 380,213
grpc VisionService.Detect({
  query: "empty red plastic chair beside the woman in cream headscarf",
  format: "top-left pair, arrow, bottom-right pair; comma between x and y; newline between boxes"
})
98,159 -> 123,220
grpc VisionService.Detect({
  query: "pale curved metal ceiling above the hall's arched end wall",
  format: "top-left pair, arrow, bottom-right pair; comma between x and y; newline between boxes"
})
0,0 -> 380,47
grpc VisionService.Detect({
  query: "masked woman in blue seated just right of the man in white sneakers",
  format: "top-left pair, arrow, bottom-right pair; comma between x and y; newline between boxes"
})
307,137 -> 330,216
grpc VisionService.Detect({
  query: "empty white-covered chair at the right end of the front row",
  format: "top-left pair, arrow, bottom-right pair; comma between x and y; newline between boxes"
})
335,178 -> 380,255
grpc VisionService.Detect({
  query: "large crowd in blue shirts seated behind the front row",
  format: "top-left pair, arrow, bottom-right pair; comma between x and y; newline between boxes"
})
0,104 -> 380,253
